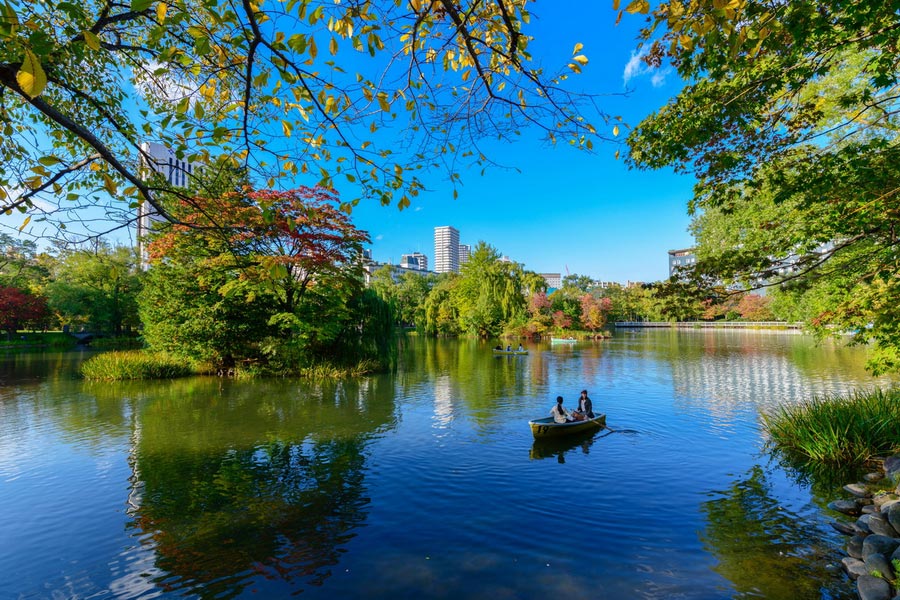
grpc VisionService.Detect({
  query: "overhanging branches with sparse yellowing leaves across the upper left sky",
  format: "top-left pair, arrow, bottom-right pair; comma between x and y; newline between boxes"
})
0,0 -> 612,241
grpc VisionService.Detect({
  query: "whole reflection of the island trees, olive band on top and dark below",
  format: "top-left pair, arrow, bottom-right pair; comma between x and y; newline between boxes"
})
120,384 -> 394,598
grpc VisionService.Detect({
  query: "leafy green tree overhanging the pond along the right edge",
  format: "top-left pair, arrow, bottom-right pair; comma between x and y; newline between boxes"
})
628,0 -> 900,372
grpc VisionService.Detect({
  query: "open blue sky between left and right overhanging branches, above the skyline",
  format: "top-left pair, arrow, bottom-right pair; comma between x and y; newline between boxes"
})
353,0 -> 693,282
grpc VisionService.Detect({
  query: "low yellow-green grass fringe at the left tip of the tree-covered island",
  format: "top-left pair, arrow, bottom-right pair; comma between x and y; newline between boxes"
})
81,350 -> 201,381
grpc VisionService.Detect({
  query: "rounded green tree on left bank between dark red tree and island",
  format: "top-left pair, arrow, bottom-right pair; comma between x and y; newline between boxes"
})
47,245 -> 141,336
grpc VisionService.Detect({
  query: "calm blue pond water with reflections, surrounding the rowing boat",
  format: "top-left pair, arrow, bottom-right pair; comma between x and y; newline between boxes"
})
0,331 -> 890,600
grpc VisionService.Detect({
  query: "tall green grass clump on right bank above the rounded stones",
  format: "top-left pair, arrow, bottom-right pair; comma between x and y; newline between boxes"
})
762,388 -> 900,465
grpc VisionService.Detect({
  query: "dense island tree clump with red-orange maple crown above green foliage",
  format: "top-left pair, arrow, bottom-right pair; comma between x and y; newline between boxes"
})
140,188 -> 394,373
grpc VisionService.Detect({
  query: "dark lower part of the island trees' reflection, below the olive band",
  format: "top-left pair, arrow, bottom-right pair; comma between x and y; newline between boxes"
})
134,440 -> 368,598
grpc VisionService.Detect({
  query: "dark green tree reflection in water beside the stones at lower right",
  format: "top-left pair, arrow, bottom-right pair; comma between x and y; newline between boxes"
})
700,466 -> 852,600
